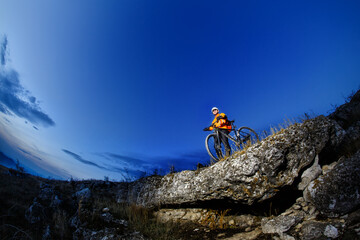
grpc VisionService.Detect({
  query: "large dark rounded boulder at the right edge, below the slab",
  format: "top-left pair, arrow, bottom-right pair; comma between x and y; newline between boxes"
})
304,150 -> 360,217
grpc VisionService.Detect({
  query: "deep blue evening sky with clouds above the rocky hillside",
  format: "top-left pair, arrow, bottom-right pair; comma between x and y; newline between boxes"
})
0,0 -> 360,180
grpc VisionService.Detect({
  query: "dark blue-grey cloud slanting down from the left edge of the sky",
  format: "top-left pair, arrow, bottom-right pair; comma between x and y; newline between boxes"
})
0,36 -> 55,127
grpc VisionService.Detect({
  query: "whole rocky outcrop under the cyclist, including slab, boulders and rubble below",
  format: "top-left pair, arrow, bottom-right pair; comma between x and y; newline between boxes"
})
118,91 -> 360,240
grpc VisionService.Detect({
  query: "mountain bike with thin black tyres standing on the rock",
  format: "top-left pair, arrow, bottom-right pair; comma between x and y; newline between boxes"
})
205,120 -> 259,161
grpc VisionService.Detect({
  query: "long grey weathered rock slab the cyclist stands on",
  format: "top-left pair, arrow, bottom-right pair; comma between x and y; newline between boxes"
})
125,116 -> 336,207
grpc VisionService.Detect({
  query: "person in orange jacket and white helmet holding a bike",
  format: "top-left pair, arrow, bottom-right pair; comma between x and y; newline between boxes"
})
204,107 -> 231,158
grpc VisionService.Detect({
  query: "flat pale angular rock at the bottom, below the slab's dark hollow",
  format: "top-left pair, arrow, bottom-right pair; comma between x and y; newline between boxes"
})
261,215 -> 301,233
